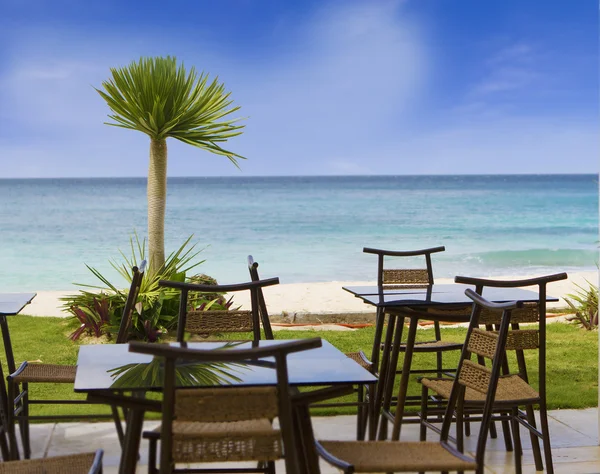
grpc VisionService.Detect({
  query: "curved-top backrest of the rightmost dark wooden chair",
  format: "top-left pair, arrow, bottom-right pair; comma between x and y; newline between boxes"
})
454,273 -> 567,392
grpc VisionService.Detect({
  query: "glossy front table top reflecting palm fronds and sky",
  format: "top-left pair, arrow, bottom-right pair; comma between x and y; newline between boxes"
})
75,340 -> 377,392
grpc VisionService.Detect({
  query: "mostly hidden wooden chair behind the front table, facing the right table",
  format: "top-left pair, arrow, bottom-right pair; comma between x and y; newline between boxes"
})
248,255 -> 373,439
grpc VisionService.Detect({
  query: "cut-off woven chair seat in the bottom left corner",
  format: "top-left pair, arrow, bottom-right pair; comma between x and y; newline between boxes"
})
0,453 -> 96,474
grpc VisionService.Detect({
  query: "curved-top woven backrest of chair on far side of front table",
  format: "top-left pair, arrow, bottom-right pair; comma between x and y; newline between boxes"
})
158,278 -> 279,342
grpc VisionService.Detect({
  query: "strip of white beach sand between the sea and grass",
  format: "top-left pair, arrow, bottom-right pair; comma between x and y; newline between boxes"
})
22,271 -> 598,319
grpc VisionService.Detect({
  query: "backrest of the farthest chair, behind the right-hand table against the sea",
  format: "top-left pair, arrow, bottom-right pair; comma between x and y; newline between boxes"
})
363,246 -> 446,287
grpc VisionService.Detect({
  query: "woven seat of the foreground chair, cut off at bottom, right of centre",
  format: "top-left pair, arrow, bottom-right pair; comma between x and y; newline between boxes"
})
319,441 -> 477,472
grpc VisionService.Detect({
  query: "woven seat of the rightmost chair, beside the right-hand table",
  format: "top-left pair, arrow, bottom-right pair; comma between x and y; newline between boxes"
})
421,375 -> 540,403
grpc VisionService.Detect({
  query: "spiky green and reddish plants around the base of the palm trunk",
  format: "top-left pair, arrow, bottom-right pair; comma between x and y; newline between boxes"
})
61,233 -> 211,342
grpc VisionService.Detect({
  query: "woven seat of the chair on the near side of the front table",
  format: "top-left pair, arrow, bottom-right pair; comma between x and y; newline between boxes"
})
153,418 -> 282,462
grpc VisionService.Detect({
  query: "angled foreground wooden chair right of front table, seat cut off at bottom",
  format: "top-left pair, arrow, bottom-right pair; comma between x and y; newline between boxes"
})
316,289 -> 518,474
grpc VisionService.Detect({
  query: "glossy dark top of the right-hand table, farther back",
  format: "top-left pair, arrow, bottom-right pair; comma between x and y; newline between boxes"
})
344,284 -> 558,307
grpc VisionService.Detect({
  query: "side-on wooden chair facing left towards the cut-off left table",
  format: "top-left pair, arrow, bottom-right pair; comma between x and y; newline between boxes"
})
5,260 -> 146,459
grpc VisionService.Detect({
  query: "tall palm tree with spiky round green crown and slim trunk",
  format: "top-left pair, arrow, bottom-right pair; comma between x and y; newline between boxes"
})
96,56 -> 244,274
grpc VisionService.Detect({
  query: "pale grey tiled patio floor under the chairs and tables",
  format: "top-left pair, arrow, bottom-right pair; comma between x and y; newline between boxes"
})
22,408 -> 600,474
